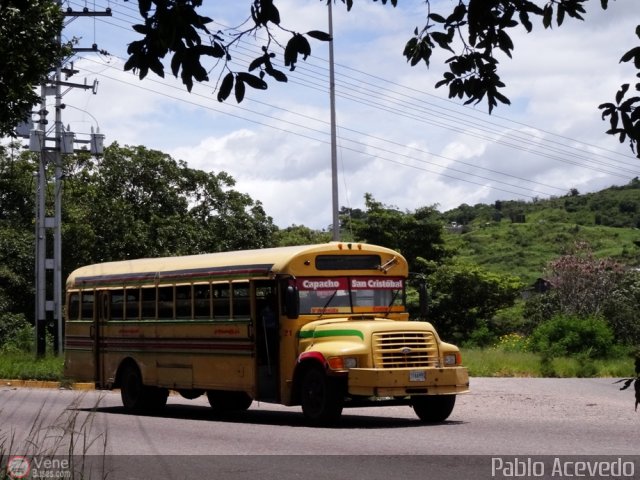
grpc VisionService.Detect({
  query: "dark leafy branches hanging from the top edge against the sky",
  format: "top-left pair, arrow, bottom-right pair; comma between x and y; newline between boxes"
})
120,0 -> 640,157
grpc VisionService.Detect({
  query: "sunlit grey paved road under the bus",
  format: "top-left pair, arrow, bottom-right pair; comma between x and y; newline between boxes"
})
0,378 -> 640,480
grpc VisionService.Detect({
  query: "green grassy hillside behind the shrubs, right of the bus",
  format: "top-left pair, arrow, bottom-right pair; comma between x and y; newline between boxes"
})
443,181 -> 640,283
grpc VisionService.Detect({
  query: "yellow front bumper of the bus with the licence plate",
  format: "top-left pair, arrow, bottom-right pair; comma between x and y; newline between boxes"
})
348,367 -> 469,397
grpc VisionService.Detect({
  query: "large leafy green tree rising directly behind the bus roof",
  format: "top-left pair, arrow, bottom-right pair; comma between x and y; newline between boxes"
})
64,144 -> 275,264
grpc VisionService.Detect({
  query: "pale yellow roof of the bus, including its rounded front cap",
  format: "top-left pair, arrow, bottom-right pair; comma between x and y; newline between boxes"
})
66,242 -> 408,289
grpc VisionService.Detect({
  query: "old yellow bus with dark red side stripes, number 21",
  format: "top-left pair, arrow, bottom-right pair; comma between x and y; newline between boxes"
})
64,242 -> 469,424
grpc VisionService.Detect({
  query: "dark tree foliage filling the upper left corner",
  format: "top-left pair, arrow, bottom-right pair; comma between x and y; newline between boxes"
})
0,0 -> 66,136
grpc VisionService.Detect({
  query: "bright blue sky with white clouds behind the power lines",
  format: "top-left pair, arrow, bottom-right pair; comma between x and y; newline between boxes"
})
22,0 -> 640,229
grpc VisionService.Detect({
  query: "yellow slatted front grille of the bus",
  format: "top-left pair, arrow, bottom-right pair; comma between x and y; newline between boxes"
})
373,332 -> 438,368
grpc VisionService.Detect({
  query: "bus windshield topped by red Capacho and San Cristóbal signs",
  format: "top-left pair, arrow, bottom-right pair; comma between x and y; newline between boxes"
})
296,277 -> 404,315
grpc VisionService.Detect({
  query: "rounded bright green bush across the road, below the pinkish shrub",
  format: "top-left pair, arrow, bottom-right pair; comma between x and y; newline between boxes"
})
531,315 -> 614,358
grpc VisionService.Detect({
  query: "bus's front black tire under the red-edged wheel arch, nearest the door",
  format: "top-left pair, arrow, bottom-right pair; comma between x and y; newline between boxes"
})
300,367 -> 344,425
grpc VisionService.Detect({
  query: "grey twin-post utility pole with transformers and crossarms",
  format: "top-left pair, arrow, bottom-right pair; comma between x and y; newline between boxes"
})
29,0 -> 111,356
